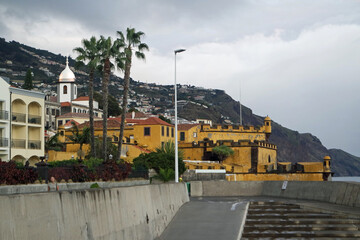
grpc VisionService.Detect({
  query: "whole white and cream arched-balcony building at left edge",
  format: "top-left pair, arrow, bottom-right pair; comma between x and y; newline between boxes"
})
0,77 -> 45,165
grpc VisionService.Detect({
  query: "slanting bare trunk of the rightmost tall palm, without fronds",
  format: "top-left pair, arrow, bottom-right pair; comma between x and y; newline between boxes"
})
117,54 -> 131,160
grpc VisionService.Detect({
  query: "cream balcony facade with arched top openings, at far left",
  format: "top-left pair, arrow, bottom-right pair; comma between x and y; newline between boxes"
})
10,87 -> 45,165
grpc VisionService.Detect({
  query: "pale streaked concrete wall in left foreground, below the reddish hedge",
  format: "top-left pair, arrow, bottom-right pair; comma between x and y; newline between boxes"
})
0,183 -> 189,240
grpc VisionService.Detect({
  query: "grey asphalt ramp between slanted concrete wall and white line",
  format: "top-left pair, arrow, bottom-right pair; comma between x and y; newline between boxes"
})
158,198 -> 248,240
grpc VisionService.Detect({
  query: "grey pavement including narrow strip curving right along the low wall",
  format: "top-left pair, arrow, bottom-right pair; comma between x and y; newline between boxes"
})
158,197 -> 360,240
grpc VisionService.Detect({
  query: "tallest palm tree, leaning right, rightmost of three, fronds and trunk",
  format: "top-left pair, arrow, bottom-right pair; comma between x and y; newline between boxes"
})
116,28 -> 149,159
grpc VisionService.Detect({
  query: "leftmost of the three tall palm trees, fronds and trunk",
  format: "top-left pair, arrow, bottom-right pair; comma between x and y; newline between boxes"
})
73,36 -> 100,156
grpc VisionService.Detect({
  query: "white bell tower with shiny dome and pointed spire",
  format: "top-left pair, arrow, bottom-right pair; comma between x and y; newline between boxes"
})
57,57 -> 77,102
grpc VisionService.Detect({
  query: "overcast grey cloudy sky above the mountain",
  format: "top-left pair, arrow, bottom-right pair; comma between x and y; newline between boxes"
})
0,0 -> 360,156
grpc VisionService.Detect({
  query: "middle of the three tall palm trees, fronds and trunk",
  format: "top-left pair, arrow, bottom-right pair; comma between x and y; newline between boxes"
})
99,36 -> 119,161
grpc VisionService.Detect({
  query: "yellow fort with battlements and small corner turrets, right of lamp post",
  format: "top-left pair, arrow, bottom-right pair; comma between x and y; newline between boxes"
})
179,117 -> 331,181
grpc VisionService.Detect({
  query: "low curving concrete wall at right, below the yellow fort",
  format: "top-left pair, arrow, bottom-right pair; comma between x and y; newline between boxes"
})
191,181 -> 360,207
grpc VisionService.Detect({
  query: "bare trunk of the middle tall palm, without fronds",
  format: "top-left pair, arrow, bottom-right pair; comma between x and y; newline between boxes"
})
102,58 -> 110,161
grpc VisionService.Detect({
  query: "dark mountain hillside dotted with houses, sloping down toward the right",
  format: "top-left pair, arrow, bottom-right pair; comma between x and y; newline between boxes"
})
0,38 -> 360,176
